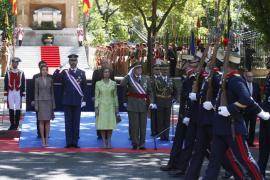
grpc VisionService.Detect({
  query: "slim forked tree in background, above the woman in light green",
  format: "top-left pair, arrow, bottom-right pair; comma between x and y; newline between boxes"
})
95,0 -> 119,33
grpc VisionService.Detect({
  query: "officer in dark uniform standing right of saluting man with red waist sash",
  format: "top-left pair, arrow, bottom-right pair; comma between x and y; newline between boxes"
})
155,63 -> 177,141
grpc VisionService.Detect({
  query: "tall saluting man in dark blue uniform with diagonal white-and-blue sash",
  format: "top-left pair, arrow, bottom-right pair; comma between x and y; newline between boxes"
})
53,54 -> 86,148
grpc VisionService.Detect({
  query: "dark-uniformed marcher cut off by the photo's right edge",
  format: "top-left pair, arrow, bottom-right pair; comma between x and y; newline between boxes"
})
258,73 -> 270,176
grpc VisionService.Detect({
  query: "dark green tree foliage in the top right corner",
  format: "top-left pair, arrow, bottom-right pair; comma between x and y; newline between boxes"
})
242,0 -> 270,50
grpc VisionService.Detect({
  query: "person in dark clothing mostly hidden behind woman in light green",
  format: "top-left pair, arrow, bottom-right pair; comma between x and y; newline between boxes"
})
91,58 -> 114,139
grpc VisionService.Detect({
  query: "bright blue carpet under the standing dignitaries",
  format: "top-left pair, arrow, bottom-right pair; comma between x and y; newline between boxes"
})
19,112 -> 172,148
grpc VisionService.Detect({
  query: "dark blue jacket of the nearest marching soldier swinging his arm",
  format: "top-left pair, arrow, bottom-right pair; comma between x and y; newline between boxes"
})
213,74 -> 261,135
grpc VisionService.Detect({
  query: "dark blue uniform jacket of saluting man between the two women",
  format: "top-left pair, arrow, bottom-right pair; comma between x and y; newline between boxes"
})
53,69 -> 86,106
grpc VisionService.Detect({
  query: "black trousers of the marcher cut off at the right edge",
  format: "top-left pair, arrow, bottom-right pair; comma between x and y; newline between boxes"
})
258,120 -> 270,176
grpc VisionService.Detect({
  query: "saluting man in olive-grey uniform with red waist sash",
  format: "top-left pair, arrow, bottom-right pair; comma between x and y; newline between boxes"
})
121,62 -> 156,150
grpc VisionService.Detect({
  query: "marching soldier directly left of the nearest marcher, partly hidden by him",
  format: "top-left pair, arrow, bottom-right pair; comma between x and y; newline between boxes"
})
185,53 -> 244,180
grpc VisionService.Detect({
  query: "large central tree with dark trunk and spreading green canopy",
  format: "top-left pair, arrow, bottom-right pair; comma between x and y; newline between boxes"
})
112,0 -> 187,73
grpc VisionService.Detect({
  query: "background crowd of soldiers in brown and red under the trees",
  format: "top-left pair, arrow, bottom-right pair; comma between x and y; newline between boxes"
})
95,42 -> 191,77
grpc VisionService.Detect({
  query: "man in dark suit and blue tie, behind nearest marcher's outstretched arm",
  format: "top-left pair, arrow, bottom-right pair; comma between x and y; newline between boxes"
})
244,72 -> 261,147
